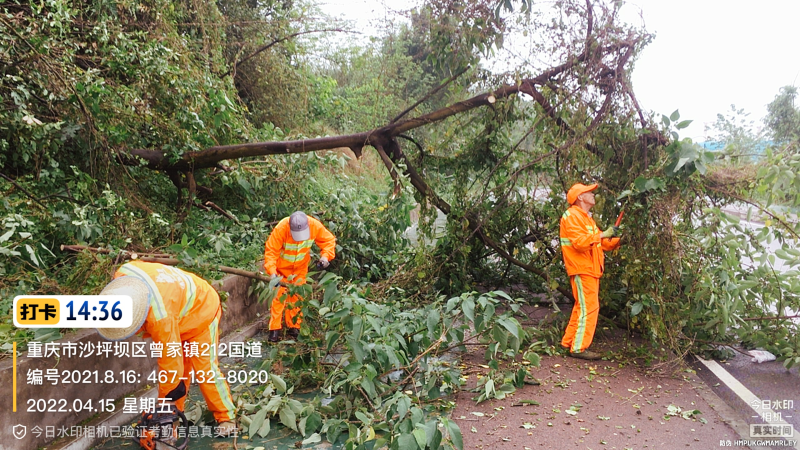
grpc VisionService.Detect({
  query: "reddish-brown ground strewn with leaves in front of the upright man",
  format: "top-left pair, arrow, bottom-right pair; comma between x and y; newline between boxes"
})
451,304 -> 740,450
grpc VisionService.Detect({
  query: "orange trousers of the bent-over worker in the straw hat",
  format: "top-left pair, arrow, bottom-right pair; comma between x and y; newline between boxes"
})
172,313 -> 236,423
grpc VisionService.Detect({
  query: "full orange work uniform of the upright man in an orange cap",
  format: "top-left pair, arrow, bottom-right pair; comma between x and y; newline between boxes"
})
560,205 -> 619,353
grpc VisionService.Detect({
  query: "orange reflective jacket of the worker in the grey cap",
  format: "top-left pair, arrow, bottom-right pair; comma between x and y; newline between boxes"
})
264,216 -> 336,284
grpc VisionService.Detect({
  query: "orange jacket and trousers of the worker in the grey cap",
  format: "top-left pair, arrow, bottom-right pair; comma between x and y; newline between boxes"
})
264,216 -> 336,330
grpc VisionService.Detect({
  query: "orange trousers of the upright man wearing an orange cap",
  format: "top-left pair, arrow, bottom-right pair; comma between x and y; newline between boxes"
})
561,275 -> 600,353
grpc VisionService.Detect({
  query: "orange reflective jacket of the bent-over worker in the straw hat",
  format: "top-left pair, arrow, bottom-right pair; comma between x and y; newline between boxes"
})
114,261 -> 221,397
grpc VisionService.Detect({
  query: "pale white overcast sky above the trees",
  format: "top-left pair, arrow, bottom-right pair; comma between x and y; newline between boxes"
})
321,0 -> 800,142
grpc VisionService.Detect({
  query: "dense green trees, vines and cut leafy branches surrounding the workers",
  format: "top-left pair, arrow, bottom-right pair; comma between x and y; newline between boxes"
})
0,0 -> 800,448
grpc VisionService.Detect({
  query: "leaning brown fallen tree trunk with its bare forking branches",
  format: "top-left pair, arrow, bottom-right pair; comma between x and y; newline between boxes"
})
119,0 -> 656,298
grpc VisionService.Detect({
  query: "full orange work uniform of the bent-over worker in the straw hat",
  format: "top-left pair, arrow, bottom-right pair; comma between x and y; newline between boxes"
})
114,261 -> 236,423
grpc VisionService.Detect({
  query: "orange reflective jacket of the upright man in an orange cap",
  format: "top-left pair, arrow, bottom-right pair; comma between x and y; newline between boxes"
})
560,205 -> 619,278
